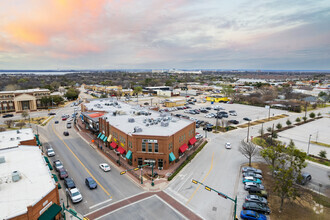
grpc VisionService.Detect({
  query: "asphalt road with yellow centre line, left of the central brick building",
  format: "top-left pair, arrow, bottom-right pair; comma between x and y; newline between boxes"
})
39,107 -> 143,214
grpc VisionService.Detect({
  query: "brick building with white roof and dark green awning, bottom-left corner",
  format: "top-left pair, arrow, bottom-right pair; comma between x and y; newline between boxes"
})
0,146 -> 61,220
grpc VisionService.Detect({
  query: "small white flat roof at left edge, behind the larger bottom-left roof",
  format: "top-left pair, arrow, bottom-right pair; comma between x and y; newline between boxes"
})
0,128 -> 34,150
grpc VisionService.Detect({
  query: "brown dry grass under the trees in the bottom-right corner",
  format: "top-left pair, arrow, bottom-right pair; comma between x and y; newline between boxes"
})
255,163 -> 330,220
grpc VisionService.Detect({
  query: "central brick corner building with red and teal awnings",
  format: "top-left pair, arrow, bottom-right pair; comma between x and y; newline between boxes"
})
82,99 -> 196,169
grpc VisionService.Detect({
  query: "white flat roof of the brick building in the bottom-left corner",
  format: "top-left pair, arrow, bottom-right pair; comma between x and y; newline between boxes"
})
0,146 -> 56,219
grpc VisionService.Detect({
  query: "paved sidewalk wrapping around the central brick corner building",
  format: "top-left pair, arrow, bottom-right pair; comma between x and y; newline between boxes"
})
74,120 -> 204,191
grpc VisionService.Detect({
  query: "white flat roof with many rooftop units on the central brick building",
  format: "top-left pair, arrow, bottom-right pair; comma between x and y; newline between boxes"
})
84,98 -> 194,136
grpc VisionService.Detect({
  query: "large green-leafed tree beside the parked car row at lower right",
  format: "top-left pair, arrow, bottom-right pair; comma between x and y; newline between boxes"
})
274,141 -> 307,211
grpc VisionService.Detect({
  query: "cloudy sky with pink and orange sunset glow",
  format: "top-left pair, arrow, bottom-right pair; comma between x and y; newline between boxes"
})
0,0 -> 330,70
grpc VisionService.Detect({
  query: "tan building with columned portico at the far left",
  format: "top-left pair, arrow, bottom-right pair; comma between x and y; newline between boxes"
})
0,89 -> 50,113
